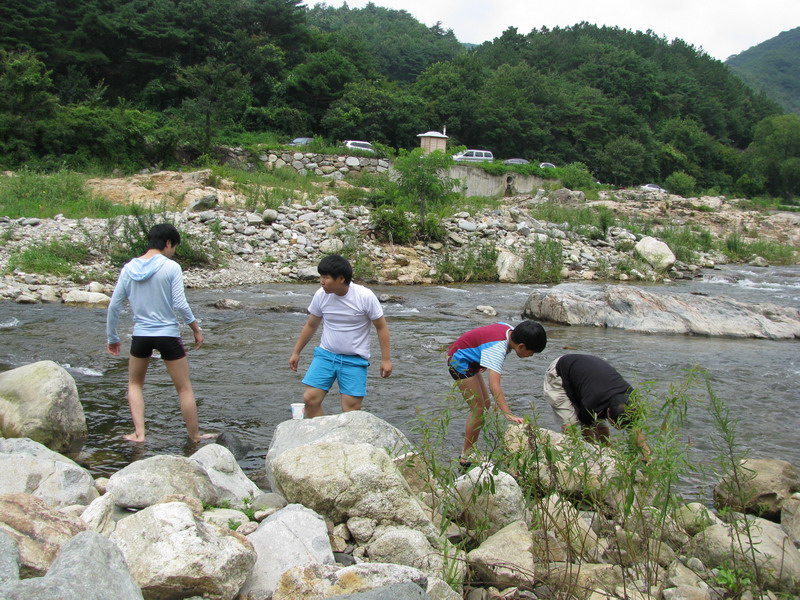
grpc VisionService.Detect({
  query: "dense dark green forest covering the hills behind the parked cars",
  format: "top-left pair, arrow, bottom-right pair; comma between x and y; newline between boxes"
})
0,0 -> 800,198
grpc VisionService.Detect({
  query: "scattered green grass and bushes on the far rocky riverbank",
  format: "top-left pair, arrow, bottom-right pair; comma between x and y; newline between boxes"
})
0,164 -> 797,283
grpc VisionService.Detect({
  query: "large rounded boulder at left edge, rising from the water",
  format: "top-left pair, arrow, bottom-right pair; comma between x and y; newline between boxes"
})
0,360 -> 87,452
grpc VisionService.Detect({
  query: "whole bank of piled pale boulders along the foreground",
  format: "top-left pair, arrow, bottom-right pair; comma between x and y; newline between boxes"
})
0,364 -> 800,600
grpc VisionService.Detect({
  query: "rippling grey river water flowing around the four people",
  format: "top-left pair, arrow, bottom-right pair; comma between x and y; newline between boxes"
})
0,267 -> 800,498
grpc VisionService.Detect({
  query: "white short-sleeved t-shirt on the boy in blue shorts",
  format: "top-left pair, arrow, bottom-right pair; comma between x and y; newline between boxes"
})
308,282 -> 383,360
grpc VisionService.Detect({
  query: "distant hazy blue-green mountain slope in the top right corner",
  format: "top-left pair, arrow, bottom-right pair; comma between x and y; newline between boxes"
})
725,27 -> 800,114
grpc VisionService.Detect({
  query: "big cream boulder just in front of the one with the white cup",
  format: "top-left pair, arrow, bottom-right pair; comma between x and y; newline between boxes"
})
272,442 -> 436,536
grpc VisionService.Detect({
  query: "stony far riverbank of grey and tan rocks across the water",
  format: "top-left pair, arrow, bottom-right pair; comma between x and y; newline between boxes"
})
0,171 -> 800,303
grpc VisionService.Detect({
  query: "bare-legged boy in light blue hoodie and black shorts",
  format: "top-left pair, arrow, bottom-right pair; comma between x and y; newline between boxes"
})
106,223 -> 215,442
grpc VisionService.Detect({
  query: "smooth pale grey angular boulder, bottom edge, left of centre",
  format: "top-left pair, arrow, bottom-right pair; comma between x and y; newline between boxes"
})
239,504 -> 335,600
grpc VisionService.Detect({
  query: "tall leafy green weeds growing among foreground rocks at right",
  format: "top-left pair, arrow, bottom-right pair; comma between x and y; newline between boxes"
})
404,367 -> 798,598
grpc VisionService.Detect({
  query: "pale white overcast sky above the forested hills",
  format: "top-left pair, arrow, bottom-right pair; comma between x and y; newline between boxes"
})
316,0 -> 800,60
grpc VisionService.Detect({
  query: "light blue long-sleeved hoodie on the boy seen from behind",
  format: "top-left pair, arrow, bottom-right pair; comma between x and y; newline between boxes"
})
106,254 -> 195,344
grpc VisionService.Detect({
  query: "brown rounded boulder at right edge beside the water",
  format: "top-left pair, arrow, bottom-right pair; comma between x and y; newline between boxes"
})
714,458 -> 800,521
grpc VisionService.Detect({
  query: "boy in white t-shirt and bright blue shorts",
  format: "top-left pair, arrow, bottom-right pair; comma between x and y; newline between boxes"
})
289,254 -> 392,418
